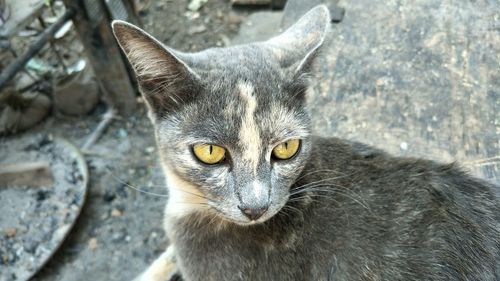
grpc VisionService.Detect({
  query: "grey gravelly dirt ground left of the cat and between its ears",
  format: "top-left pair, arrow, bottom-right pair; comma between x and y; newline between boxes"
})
0,0 -> 252,281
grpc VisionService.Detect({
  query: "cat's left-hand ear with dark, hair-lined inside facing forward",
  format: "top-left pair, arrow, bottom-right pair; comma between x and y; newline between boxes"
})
112,20 -> 198,117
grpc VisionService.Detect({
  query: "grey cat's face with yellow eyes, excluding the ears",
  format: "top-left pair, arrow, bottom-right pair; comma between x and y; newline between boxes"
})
156,77 -> 310,224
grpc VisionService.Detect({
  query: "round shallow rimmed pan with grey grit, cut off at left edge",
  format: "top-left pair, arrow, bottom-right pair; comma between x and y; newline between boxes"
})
0,135 -> 88,280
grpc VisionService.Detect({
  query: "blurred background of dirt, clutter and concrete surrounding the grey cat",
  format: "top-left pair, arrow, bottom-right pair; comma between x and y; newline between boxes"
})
0,0 -> 500,281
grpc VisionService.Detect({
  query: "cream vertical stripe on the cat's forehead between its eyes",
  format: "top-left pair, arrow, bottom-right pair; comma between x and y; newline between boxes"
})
237,82 -> 261,175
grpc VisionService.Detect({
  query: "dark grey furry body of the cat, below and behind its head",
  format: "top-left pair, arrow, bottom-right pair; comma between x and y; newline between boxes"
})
167,138 -> 500,280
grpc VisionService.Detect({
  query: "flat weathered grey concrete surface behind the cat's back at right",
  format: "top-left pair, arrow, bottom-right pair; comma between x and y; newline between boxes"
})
310,0 -> 500,184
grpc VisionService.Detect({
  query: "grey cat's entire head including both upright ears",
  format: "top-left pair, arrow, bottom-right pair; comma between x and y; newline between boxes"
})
113,6 -> 330,225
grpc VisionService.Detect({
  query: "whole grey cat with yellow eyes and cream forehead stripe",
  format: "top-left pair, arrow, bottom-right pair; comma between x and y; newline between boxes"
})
112,6 -> 500,281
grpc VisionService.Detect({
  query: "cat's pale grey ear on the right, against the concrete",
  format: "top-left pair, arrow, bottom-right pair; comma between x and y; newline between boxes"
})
265,5 -> 331,75
